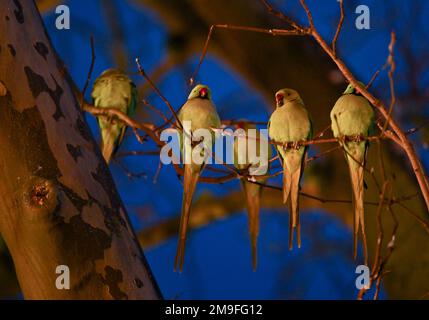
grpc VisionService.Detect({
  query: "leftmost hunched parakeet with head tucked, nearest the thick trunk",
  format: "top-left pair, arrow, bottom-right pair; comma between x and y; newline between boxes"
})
91,69 -> 137,163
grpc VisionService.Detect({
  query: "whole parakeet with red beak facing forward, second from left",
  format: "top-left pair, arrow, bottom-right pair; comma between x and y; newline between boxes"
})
174,84 -> 221,272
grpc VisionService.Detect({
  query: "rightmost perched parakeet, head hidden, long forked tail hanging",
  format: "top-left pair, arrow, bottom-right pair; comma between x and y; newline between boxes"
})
331,83 -> 375,264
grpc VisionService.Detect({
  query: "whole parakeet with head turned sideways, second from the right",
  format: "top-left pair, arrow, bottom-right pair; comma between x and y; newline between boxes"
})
268,89 -> 313,249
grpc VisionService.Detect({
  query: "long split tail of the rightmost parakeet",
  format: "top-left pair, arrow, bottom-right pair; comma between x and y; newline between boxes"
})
349,160 -> 368,264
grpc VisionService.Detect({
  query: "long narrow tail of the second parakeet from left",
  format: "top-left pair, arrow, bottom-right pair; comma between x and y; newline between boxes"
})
174,164 -> 200,272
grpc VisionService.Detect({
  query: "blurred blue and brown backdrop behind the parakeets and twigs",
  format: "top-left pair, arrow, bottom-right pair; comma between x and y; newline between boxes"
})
0,0 -> 429,299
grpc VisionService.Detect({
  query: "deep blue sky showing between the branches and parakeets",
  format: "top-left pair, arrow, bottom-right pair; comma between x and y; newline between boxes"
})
40,0 -> 429,299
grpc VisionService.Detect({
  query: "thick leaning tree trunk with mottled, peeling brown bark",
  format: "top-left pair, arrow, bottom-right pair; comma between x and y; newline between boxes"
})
0,0 -> 161,299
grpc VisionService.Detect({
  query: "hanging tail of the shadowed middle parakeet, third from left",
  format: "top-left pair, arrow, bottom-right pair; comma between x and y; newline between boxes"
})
242,180 -> 261,271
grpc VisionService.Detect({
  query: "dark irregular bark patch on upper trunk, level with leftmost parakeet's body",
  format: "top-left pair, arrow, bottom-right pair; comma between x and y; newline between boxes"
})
24,66 -> 64,121
